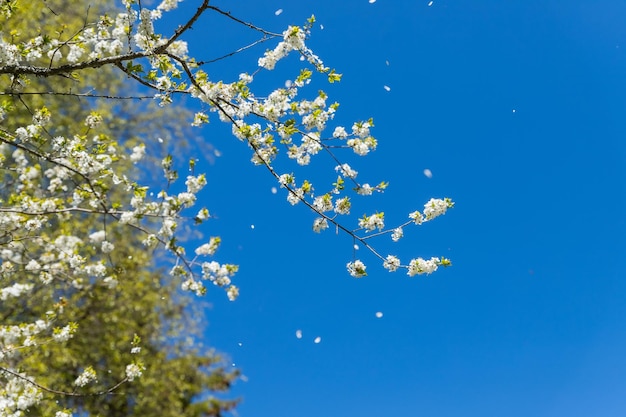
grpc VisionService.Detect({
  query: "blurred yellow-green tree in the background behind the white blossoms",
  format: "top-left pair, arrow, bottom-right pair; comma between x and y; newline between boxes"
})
0,0 -> 238,417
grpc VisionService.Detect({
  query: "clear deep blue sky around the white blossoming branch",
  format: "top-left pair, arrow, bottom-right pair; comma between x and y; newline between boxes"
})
162,0 -> 626,417
